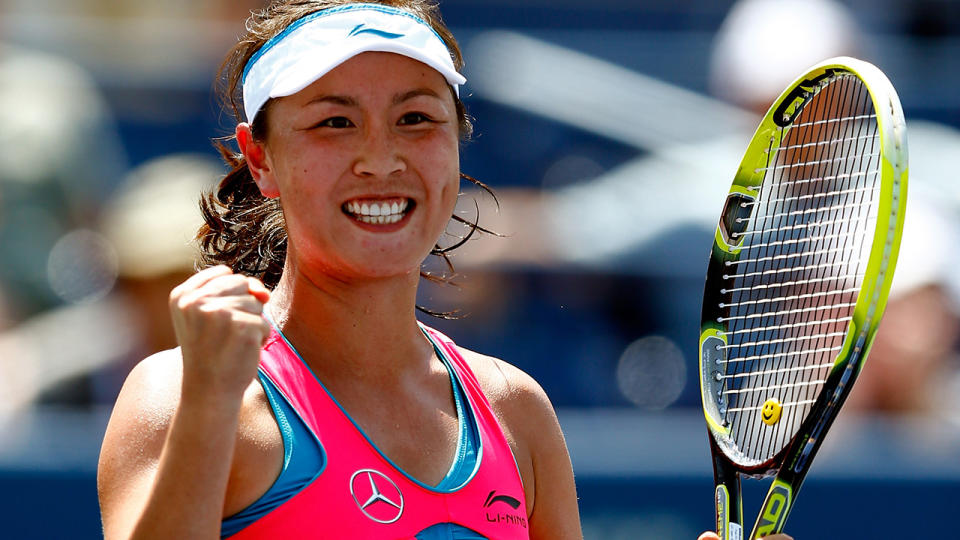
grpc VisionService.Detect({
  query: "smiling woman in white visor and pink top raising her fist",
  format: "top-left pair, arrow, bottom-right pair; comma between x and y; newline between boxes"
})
98,0 -> 581,540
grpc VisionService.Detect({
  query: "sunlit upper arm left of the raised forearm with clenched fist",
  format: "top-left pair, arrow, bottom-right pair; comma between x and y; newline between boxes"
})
97,350 -> 181,538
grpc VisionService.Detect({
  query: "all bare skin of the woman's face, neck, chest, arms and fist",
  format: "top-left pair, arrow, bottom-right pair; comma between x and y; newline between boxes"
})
98,53 -> 582,540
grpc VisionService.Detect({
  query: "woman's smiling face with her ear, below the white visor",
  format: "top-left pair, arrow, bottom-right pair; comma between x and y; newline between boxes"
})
237,52 -> 460,278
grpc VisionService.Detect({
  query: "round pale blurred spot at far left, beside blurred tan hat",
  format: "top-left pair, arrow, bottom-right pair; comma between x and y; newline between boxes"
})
47,229 -> 117,304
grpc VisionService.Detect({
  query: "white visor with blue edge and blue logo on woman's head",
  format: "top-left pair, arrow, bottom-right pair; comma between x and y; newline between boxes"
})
243,4 -> 467,122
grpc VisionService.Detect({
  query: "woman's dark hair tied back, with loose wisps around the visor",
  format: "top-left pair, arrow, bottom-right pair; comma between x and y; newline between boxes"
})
197,0 -> 492,300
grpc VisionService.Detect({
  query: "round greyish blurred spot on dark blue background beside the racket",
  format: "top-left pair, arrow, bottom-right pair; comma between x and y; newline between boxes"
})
617,336 -> 687,409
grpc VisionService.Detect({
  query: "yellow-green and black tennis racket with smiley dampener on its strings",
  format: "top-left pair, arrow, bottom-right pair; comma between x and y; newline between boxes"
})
700,57 -> 907,540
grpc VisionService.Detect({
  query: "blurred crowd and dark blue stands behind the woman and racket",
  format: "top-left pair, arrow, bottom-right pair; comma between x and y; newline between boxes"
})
0,0 -> 960,539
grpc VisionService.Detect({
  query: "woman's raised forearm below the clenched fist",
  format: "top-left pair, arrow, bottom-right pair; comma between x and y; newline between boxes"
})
131,385 -> 241,539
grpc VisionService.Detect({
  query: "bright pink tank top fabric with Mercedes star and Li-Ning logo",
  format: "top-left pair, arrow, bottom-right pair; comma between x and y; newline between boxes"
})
231,326 -> 529,540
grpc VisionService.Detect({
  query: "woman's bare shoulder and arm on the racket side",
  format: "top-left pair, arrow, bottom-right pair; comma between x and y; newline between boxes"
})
462,353 -> 583,539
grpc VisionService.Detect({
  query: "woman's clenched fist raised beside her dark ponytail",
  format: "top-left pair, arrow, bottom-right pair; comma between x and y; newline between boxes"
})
170,266 -> 270,397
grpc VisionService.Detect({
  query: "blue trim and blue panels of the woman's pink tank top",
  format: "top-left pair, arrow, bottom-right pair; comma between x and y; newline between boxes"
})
220,320 -> 483,540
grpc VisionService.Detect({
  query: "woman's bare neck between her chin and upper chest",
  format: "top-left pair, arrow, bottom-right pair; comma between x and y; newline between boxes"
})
267,258 -> 433,382
